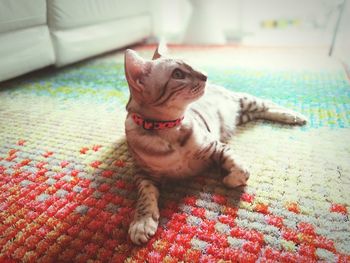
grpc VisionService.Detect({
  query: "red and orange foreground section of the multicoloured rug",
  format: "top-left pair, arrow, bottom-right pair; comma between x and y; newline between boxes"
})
0,139 -> 350,262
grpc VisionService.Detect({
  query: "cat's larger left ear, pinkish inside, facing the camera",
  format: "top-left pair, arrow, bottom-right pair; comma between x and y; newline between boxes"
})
124,49 -> 150,93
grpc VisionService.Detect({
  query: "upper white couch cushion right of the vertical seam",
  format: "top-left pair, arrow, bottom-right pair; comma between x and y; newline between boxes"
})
48,0 -> 150,30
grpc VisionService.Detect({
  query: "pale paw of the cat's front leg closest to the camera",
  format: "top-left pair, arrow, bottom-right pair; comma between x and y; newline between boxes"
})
129,216 -> 158,245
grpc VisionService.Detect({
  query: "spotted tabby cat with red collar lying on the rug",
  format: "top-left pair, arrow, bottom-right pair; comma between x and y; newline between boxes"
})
125,46 -> 306,245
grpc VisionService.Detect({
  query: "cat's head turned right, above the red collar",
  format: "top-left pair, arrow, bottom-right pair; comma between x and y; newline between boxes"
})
125,49 -> 207,119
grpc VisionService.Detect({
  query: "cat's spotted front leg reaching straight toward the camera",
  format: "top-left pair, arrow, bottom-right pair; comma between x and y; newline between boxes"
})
129,174 -> 159,245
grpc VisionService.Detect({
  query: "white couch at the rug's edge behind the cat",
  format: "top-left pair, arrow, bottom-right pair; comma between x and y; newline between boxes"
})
0,0 -> 152,81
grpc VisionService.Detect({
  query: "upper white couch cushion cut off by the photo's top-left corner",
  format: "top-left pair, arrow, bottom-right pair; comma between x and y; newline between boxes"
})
0,0 -> 46,33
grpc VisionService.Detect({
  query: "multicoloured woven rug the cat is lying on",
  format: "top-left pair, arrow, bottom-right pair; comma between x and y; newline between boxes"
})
0,47 -> 350,263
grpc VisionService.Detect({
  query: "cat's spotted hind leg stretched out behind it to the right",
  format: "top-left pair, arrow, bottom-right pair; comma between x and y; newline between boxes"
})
237,93 -> 307,125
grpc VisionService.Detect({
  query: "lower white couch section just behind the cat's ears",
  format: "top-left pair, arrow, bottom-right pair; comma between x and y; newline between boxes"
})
51,15 -> 152,66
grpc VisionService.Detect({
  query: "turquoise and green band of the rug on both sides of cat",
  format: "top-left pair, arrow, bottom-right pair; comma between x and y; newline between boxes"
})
2,50 -> 350,128
